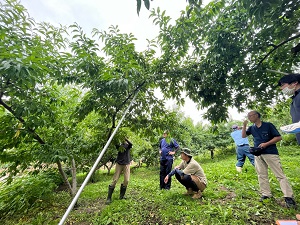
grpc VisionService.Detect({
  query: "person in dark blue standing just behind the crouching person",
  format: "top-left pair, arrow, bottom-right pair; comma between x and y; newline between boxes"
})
159,130 -> 179,190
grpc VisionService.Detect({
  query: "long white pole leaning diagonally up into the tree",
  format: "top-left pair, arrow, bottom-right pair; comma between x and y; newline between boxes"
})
59,91 -> 139,225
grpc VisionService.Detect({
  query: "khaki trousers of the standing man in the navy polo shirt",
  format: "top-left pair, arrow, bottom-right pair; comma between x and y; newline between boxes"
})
255,154 -> 293,197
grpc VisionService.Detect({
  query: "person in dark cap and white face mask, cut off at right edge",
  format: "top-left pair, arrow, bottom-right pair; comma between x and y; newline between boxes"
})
278,73 -> 300,145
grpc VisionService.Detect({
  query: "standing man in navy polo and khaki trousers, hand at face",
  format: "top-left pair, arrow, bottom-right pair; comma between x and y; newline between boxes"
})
242,111 -> 296,208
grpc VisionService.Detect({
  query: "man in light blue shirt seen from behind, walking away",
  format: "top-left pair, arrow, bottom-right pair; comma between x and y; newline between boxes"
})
230,125 -> 254,172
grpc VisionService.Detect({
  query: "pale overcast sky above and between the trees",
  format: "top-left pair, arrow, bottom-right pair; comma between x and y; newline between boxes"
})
20,0 -> 244,123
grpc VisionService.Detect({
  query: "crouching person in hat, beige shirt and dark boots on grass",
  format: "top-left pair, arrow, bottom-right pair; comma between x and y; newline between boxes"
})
164,148 -> 207,199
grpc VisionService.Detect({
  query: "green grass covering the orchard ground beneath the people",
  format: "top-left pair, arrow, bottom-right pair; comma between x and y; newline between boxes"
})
0,146 -> 300,225
